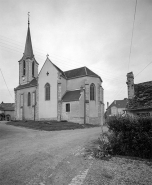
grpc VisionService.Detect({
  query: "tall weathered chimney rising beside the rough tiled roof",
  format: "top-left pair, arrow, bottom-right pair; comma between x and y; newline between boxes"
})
126,72 -> 134,99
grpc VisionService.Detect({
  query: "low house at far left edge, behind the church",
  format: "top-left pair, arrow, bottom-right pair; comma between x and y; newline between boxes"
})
0,102 -> 15,121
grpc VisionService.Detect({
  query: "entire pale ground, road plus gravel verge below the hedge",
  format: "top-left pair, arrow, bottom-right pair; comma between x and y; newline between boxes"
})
0,122 -> 152,185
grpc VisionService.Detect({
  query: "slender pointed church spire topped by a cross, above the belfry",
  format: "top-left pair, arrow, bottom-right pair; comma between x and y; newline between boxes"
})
24,12 -> 34,58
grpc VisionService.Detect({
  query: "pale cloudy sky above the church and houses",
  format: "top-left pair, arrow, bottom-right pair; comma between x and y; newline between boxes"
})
0,0 -> 152,109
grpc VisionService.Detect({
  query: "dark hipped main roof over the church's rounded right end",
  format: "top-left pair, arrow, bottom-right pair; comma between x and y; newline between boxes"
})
64,67 -> 102,81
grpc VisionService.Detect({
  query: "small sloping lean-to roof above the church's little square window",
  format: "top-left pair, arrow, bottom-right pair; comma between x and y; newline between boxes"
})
62,90 -> 81,102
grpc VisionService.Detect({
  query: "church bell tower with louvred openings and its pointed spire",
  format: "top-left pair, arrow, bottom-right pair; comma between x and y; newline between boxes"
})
19,13 -> 39,85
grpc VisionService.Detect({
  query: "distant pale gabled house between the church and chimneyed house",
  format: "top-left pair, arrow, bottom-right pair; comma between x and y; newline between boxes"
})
105,98 -> 127,118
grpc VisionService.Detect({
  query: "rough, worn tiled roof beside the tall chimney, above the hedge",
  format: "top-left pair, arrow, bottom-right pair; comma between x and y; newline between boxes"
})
127,81 -> 152,110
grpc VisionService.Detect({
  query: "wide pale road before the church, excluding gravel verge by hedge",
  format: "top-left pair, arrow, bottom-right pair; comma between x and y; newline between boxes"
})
0,122 -> 101,185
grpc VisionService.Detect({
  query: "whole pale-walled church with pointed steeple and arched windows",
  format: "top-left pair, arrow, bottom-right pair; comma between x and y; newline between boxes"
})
14,19 -> 104,125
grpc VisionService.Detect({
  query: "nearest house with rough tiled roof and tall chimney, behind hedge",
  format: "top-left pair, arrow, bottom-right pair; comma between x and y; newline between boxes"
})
126,72 -> 152,116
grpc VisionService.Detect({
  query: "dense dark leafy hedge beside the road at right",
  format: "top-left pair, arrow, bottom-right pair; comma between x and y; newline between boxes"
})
101,116 -> 152,158
